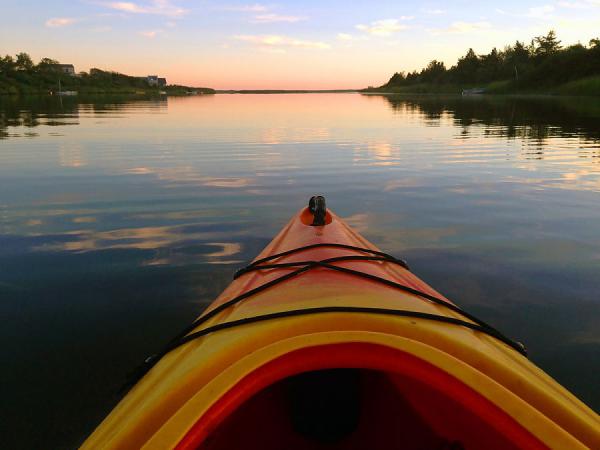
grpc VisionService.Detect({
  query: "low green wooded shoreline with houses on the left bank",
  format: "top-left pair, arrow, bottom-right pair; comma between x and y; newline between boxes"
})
0,53 -> 214,94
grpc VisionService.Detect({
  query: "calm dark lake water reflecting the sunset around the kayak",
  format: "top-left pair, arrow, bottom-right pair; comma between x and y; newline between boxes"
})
0,94 -> 600,448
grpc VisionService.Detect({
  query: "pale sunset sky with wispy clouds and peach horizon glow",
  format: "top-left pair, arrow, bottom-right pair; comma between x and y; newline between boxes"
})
0,0 -> 600,89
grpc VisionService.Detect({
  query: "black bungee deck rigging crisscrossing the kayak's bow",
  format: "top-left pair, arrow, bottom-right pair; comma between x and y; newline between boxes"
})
126,243 -> 527,387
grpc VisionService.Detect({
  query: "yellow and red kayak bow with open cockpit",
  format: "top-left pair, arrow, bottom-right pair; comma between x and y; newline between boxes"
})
82,197 -> 600,450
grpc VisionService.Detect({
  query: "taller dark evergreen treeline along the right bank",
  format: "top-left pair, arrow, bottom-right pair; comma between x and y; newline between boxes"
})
380,31 -> 600,89
